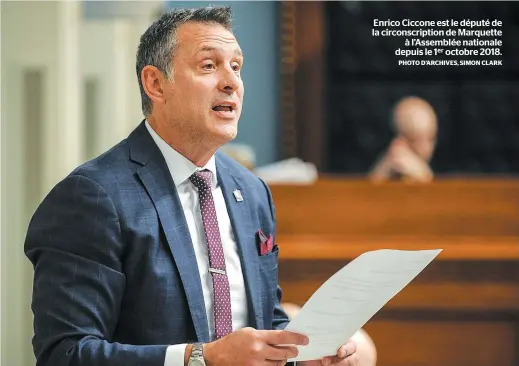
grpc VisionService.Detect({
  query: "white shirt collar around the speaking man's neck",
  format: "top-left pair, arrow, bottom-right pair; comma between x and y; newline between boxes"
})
145,120 -> 218,189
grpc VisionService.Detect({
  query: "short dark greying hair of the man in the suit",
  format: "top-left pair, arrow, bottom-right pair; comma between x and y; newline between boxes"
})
136,6 -> 232,116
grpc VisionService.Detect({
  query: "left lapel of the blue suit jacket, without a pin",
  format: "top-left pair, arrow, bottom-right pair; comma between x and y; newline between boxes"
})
130,124 -> 210,342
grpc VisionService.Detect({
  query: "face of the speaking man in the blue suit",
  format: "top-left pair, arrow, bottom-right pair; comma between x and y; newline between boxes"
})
164,22 -> 244,144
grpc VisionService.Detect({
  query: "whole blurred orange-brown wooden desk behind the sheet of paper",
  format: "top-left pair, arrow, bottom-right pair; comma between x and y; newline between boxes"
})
271,178 -> 519,366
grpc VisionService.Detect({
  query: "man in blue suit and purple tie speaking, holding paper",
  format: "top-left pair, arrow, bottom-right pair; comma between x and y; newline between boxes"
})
25,8 -> 366,366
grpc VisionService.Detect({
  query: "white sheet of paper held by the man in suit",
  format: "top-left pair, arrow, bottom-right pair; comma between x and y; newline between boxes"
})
285,249 -> 442,361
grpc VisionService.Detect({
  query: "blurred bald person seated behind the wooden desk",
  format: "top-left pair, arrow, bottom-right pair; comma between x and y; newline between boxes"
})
370,96 -> 438,182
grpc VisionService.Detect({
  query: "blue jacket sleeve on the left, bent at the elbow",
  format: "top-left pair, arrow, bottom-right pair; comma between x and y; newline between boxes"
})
25,175 -> 167,366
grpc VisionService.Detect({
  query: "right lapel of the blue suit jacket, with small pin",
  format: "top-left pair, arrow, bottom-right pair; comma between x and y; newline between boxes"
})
216,154 -> 263,329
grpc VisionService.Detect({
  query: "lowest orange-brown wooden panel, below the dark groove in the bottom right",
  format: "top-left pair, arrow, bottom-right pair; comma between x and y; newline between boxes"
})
365,321 -> 518,366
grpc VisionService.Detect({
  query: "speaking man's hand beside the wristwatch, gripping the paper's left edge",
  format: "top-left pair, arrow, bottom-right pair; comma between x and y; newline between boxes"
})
204,328 -> 308,366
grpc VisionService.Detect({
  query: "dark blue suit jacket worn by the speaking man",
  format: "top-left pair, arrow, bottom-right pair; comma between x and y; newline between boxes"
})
25,123 -> 288,366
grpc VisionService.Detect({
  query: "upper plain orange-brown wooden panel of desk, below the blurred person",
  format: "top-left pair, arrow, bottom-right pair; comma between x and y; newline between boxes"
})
271,178 -> 519,237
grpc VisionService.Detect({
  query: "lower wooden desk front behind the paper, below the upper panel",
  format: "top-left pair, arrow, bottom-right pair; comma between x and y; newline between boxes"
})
279,260 -> 519,366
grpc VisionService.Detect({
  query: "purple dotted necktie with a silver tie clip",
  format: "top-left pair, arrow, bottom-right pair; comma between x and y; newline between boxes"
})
189,170 -> 232,339
